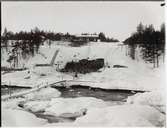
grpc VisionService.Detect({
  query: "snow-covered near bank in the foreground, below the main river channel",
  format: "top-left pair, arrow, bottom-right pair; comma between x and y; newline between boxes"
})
2,91 -> 166,127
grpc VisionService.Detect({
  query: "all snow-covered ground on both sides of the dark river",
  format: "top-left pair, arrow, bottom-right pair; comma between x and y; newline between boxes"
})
1,42 -> 166,127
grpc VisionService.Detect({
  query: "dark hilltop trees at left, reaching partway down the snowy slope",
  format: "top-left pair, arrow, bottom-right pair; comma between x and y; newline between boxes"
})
1,27 -> 118,67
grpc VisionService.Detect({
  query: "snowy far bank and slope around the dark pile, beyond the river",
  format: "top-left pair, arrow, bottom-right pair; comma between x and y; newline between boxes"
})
2,42 -> 165,91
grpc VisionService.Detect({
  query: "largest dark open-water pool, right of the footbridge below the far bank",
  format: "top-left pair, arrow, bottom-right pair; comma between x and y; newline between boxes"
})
53,85 -> 134,101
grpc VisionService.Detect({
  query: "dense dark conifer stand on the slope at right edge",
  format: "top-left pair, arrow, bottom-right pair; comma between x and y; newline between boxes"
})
123,22 -> 165,68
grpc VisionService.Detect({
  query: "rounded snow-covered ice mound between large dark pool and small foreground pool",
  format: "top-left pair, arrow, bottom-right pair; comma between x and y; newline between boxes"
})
45,97 -> 106,115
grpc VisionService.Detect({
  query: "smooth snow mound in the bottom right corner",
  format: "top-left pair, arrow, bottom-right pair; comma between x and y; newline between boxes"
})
75,105 -> 165,127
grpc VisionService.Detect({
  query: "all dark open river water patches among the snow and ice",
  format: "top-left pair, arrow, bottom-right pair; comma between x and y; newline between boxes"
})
1,85 -> 135,123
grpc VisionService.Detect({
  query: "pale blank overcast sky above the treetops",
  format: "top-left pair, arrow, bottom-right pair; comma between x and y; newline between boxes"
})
1,1 -> 165,40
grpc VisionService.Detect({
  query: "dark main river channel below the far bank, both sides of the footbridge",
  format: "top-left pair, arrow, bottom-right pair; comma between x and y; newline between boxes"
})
1,85 -> 137,101
